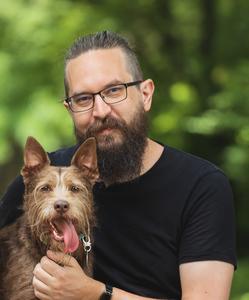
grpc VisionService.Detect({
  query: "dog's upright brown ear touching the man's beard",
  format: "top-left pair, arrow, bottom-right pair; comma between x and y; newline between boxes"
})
71,137 -> 99,184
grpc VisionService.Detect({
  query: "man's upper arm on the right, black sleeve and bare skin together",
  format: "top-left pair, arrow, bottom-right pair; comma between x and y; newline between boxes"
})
179,172 -> 236,300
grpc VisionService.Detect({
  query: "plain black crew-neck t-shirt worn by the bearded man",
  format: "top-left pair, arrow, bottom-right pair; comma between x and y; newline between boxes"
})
0,146 -> 236,299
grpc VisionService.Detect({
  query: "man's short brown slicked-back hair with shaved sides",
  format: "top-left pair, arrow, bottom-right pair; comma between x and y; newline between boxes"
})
64,30 -> 143,97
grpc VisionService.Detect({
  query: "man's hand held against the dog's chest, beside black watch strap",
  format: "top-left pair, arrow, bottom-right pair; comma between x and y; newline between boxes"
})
33,251 -> 104,300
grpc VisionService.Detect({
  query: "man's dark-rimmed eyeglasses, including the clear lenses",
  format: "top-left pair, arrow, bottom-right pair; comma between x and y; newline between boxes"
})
64,80 -> 142,112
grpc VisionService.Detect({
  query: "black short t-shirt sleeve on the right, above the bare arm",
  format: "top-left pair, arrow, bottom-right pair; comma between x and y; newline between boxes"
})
179,171 -> 236,268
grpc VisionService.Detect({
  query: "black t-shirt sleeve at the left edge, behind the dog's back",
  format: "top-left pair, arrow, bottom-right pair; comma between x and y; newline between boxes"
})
0,176 -> 24,228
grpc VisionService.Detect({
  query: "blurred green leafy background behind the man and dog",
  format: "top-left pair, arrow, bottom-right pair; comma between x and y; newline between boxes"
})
0,0 -> 249,300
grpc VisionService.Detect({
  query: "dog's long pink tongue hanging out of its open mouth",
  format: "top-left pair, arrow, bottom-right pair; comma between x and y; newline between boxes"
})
61,221 -> 79,253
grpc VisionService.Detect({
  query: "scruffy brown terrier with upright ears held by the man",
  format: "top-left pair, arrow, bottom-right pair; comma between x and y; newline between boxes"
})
0,137 -> 98,300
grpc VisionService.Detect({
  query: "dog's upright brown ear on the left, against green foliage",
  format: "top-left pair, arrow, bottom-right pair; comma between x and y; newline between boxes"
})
21,136 -> 50,177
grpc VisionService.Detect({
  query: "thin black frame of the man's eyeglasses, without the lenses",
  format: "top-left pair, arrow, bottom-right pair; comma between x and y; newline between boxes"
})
64,80 -> 143,113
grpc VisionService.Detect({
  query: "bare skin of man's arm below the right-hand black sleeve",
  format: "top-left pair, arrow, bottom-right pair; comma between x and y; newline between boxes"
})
180,261 -> 234,300
